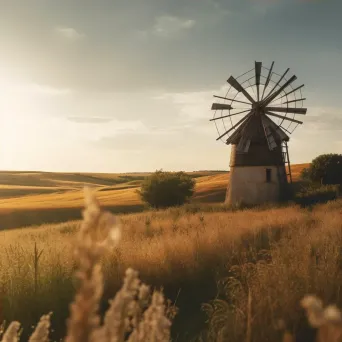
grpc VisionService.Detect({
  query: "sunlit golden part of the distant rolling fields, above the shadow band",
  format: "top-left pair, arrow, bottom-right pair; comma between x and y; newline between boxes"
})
0,164 -> 308,210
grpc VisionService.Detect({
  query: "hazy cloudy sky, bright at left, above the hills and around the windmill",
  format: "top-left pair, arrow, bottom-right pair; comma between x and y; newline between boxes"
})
0,0 -> 342,172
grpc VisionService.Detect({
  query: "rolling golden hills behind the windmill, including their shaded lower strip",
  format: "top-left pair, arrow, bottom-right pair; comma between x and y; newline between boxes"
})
0,164 -> 308,229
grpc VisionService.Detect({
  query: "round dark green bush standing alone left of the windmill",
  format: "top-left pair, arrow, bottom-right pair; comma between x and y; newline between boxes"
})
139,170 -> 195,208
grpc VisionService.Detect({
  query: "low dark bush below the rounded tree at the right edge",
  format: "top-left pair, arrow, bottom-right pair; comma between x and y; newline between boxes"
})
295,185 -> 339,206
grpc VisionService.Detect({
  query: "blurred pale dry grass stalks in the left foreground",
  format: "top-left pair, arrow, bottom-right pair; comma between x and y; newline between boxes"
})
2,188 -> 171,342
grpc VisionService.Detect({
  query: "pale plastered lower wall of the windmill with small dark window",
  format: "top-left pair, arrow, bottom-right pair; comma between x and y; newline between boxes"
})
226,166 -> 287,205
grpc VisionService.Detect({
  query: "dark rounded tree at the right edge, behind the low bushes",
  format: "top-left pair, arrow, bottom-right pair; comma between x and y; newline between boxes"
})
301,153 -> 342,185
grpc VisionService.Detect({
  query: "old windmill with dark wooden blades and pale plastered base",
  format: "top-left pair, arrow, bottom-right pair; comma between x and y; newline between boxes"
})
210,62 -> 307,204
